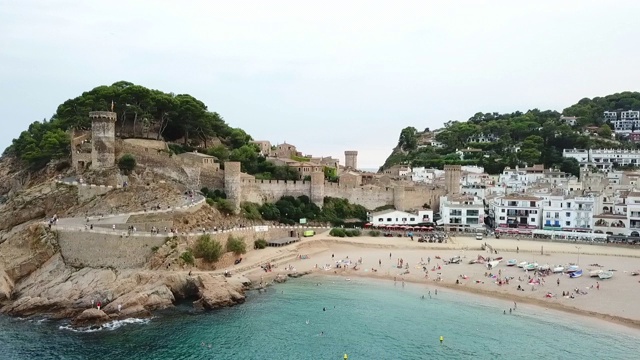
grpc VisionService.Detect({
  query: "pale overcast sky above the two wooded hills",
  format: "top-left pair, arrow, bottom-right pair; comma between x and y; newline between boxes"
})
0,0 -> 640,168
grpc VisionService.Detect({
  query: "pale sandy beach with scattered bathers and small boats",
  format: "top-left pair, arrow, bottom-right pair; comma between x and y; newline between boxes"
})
245,234 -> 640,329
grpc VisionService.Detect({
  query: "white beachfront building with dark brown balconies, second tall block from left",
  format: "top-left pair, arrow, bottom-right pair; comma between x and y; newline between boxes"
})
489,194 -> 543,233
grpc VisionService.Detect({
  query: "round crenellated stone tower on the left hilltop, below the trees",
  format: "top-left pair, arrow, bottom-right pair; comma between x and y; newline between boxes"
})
89,111 -> 117,169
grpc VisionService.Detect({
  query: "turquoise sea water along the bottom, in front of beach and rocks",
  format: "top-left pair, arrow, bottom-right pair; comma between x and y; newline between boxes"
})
0,278 -> 640,360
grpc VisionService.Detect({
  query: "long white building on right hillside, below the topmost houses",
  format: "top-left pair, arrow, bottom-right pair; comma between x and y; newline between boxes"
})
562,149 -> 640,172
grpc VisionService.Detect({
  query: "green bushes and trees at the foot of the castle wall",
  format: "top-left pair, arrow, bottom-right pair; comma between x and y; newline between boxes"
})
240,195 -> 367,225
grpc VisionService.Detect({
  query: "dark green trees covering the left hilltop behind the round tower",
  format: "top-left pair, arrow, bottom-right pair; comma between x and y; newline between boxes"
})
4,81 -> 299,180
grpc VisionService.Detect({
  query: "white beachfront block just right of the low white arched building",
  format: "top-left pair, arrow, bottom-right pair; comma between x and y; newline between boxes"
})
438,195 -> 484,231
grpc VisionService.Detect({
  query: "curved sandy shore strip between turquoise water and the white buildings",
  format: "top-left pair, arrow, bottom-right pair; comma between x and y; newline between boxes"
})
246,237 -> 640,330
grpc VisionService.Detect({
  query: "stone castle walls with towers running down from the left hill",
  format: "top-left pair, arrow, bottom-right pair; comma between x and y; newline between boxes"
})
71,111 -> 450,211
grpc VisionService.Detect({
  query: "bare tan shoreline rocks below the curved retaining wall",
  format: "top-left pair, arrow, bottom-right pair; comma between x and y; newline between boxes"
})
1,254 -> 245,325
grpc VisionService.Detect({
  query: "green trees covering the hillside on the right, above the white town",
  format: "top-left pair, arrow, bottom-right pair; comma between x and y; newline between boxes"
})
383,92 -> 640,175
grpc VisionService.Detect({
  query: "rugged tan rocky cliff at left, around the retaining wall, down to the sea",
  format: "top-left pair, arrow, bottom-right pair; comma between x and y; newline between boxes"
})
0,159 -> 255,326
